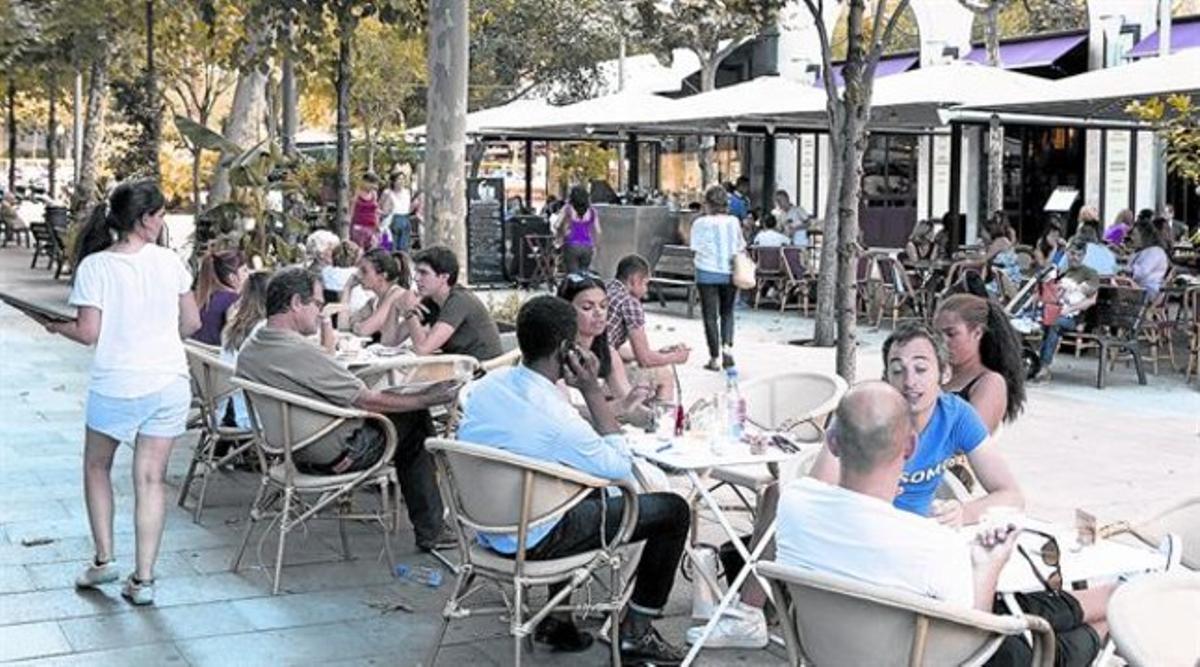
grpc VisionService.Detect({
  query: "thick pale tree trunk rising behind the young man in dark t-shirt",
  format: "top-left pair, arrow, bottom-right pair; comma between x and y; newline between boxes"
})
424,0 -> 469,265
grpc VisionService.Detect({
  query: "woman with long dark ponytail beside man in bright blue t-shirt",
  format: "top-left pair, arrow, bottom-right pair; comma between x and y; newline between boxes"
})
934,294 -> 1025,433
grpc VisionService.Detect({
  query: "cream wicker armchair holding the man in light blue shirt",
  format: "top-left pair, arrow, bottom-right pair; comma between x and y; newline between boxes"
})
424,438 -> 637,667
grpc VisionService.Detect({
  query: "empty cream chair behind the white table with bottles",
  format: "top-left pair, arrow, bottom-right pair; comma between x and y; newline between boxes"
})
709,371 -> 848,511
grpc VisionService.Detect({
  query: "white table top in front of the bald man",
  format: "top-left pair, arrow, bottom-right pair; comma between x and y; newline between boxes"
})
979,518 -> 1166,593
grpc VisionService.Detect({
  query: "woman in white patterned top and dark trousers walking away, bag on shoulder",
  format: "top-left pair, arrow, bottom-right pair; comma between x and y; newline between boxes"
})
689,185 -> 745,371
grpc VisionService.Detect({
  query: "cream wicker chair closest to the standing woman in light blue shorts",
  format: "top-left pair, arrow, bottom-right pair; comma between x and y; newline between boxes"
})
179,341 -> 254,523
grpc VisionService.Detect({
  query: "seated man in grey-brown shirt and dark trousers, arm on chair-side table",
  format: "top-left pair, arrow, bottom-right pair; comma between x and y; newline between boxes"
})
235,268 -> 457,551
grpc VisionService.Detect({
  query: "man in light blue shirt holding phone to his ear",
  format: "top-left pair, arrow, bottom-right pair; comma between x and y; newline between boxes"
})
458,296 -> 690,665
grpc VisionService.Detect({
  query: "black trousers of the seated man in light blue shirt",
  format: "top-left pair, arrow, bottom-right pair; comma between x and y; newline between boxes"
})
526,493 -> 691,615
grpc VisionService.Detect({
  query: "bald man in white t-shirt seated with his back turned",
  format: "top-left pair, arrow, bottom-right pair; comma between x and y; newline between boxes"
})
776,381 -> 1116,666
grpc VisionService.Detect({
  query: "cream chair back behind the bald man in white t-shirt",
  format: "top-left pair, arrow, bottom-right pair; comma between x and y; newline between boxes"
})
757,561 -> 1055,667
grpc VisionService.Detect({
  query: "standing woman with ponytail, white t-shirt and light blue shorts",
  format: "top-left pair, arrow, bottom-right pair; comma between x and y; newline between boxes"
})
46,181 -> 200,605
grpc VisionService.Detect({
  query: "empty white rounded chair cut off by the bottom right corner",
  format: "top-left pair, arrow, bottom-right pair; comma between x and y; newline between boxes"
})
1108,570 -> 1200,667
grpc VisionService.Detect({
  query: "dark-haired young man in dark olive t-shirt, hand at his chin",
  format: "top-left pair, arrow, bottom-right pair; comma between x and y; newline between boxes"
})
401,246 -> 504,361
